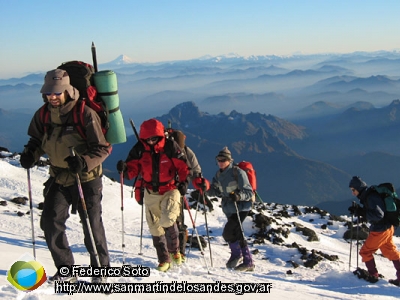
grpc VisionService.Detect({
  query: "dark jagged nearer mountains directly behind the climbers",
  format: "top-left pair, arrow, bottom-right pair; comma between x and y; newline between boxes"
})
113,100 -> 400,214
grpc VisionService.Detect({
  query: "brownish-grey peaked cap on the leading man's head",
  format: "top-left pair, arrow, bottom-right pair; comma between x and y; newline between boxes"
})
40,69 -> 75,98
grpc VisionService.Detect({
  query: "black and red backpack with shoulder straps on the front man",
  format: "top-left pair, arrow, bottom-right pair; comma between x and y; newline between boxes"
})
40,60 -> 109,139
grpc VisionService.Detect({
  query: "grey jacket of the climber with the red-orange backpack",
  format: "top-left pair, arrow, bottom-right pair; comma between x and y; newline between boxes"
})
207,162 -> 253,218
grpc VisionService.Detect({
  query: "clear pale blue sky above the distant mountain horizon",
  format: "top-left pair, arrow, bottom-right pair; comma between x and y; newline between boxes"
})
0,0 -> 400,78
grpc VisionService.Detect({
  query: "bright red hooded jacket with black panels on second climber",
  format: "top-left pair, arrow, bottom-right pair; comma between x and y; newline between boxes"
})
126,119 -> 189,195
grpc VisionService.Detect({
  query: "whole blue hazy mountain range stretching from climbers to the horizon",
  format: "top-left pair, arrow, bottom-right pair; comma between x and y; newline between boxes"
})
0,51 -> 400,216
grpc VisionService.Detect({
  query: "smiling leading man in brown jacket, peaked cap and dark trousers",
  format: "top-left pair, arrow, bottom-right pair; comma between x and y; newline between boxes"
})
20,69 -> 111,283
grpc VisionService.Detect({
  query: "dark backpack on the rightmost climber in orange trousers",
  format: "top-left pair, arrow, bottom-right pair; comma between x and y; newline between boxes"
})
370,182 -> 400,227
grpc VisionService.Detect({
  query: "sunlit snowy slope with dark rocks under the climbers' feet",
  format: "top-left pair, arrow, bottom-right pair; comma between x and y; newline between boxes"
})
0,153 -> 400,300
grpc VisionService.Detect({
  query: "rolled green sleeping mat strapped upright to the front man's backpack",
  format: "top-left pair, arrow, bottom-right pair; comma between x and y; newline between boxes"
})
93,70 -> 126,144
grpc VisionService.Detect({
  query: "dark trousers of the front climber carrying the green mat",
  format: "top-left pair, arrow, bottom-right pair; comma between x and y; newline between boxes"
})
40,178 -> 110,268
